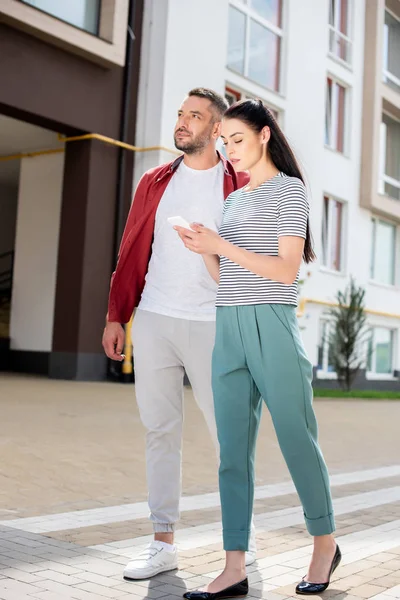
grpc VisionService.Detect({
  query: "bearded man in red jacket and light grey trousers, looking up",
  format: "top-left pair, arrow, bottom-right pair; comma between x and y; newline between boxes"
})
103,88 -> 255,579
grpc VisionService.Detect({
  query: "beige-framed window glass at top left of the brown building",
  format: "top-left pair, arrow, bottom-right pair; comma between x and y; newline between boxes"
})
22,0 -> 100,35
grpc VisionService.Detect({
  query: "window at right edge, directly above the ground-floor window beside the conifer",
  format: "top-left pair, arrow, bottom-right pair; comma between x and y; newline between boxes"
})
371,218 -> 396,285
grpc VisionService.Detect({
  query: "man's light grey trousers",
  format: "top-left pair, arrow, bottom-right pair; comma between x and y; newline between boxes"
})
132,310 -> 219,532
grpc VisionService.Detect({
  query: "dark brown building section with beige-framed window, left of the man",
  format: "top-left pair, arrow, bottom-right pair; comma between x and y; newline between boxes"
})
0,0 -> 143,379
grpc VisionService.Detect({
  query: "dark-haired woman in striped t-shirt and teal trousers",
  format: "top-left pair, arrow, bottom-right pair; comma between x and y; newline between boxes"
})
176,100 -> 341,600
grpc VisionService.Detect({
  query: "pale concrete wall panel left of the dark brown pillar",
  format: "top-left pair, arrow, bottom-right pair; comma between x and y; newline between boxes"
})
10,154 -> 64,352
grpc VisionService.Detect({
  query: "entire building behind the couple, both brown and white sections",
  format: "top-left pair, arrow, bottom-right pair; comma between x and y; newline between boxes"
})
0,0 -> 400,389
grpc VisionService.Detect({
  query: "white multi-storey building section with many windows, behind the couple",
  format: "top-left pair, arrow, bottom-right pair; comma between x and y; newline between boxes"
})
135,0 -> 400,389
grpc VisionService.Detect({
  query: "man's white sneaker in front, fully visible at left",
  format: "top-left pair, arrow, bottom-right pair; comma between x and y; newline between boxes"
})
124,541 -> 178,579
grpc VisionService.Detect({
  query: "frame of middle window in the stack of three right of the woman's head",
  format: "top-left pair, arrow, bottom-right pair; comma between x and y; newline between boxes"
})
324,73 -> 351,157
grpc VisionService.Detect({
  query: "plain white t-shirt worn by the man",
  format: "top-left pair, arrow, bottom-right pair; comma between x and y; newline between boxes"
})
138,161 -> 224,321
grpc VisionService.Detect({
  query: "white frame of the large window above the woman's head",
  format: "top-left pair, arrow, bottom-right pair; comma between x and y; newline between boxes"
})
226,0 -> 287,94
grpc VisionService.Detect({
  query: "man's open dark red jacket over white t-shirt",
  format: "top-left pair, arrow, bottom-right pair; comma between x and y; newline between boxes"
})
107,155 -> 249,323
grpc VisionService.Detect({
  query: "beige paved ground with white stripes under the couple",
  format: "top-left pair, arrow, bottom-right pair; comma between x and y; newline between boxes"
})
0,375 -> 400,600
